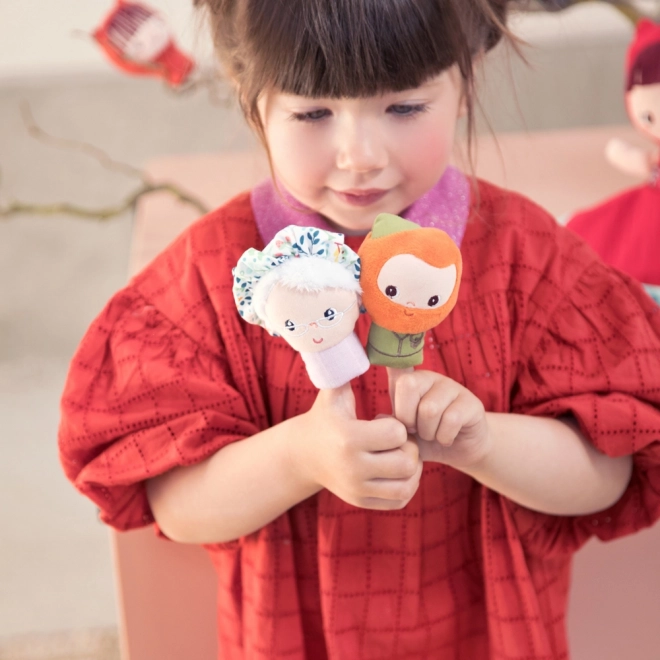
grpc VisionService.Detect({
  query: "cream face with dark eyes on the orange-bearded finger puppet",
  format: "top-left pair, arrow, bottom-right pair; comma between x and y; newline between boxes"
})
378,254 -> 457,319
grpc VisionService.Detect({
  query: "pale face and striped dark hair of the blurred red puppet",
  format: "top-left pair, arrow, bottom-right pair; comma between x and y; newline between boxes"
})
108,5 -> 171,64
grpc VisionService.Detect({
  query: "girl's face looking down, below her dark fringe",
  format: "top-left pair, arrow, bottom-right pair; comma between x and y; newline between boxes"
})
259,66 -> 464,234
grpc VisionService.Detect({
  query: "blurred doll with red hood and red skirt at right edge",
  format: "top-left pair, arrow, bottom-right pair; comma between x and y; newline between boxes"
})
568,20 -> 660,303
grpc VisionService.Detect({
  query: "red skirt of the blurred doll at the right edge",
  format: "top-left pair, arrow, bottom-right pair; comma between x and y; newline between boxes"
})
567,184 -> 660,285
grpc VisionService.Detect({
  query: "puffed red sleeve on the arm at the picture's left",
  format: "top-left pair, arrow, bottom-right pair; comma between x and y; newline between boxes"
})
59,287 -> 260,530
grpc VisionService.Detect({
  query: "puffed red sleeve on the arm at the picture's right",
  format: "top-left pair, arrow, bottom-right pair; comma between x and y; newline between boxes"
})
511,253 -> 660,557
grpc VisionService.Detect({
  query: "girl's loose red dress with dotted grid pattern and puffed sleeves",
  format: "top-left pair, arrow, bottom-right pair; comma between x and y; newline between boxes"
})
59,178 -> 660,660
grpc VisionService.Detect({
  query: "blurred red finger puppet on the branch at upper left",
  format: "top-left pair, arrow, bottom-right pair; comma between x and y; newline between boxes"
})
93,0 -> 195,87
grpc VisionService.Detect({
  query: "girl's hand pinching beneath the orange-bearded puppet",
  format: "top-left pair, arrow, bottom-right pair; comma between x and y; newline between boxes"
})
389,370 -> 492,469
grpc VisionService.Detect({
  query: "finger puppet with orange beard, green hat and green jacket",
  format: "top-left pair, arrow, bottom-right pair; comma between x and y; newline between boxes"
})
358,213 -> 463,369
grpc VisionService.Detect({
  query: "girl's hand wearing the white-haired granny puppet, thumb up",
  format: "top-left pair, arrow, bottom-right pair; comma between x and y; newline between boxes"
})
290,383 -> 422,510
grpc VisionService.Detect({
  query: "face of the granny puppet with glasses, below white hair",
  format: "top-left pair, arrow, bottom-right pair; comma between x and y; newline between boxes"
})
265,284 -> 360,353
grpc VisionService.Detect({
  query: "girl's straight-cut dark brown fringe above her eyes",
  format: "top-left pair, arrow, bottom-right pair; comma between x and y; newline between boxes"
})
248,0 -> 471,98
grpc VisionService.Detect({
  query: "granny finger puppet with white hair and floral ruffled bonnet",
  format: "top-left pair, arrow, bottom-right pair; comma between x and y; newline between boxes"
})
233,225 -> 369,389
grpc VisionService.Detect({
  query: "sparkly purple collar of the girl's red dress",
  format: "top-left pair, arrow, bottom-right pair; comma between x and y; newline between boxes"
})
251,167 -> 470,247
